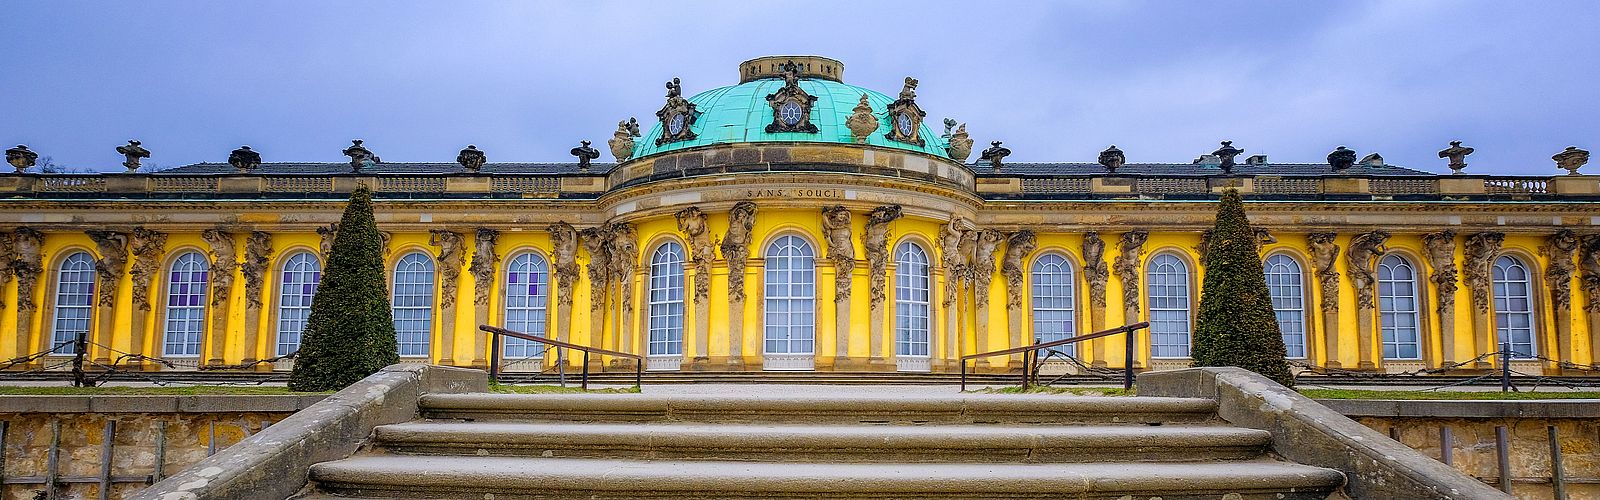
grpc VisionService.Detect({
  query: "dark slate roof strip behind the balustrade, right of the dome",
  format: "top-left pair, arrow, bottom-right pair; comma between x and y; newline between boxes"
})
973,162 -> 1437,176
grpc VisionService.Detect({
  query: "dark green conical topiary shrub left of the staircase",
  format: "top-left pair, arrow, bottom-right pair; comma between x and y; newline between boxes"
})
290,188 -> 400,391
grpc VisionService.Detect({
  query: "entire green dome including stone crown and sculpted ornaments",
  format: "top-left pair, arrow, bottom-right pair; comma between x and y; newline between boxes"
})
632,56 -> 947,159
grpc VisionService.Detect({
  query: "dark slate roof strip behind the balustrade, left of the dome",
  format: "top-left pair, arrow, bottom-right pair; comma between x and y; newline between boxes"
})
152,162 -> 616,176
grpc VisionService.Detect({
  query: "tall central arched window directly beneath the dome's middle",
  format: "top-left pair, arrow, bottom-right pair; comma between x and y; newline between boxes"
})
765,236 -> 812,354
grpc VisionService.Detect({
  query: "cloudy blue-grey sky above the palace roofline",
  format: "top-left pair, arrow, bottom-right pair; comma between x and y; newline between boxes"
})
0,0 -> 1600,175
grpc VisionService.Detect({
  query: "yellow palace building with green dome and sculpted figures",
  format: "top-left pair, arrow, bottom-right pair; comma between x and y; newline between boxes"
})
0,56 -> 1600,375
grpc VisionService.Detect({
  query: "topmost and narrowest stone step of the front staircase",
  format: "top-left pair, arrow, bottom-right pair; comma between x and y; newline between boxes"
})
419,393 -> 1219,425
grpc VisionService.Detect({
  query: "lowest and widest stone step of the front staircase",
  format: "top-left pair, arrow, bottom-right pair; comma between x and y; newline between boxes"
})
310,455 -> 1344,500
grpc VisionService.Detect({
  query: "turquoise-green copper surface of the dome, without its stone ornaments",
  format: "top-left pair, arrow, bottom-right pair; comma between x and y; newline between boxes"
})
634,59 -> 947,159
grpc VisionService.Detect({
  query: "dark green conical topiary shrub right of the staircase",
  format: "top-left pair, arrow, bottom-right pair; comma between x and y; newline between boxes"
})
1194,189 -> 1294,386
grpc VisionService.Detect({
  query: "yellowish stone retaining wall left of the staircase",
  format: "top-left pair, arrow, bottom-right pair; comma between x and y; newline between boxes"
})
0,396 -> 325,500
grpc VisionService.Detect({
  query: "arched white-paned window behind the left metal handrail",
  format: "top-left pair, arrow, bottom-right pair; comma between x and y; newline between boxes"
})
501,252 -> 550,359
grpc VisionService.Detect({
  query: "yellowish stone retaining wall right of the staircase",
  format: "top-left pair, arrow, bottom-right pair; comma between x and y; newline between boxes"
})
1318,399 -> 1600,498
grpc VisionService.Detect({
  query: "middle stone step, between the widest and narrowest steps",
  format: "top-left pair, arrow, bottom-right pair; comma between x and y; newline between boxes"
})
376,421 -> 1272,463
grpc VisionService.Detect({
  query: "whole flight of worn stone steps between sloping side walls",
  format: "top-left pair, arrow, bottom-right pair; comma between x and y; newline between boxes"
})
302,394 -> 1344,500
